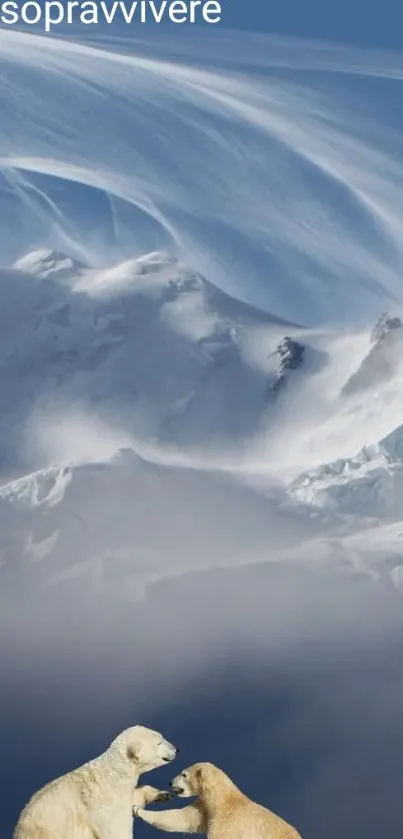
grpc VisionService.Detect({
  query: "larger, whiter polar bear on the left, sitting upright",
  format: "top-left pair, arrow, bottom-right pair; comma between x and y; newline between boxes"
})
13,726 -> 178,839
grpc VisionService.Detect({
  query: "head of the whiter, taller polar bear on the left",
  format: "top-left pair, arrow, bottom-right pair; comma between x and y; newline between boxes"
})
108,725 -> 178,775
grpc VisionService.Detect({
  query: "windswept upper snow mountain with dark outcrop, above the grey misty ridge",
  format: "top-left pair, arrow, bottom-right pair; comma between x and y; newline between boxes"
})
0,250 -> 403,481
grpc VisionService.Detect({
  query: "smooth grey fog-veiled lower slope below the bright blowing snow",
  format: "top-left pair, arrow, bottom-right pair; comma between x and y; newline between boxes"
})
0,449 -> 340,599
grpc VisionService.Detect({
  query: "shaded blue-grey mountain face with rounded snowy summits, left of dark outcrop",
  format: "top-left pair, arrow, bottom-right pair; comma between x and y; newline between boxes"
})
0,251 -> 306,466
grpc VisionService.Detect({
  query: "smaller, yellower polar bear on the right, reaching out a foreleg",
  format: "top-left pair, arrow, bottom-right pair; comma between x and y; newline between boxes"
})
134,763 -> 301,839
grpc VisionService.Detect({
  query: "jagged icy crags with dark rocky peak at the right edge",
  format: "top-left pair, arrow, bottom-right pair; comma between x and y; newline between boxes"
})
289,314 -> 403,521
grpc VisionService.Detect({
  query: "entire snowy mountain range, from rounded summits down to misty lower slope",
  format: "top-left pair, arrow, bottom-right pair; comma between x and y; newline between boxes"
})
0,243 -> 403,596
